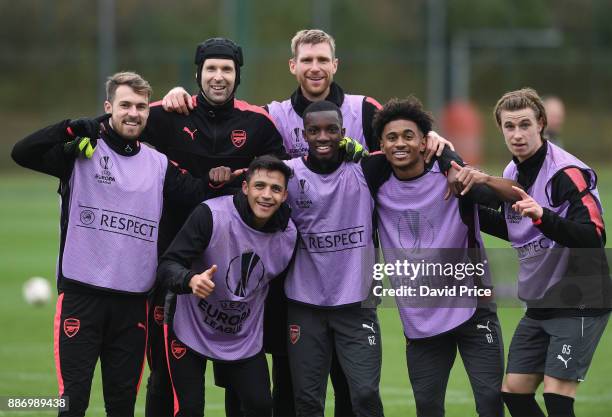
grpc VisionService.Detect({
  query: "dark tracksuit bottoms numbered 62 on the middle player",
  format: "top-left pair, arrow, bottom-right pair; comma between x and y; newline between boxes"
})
288,302 -> 383,417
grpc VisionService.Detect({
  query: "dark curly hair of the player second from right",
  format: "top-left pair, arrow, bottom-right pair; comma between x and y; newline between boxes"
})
372,95 -> 434,140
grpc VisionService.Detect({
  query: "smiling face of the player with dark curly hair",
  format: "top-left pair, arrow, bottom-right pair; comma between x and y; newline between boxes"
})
380,119 -> 426,179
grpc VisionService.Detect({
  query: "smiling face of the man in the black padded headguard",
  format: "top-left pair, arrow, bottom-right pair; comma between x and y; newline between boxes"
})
200,58 -> 236,106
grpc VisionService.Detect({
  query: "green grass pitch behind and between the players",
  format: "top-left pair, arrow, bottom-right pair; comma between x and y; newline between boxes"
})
0,169 -> 612,417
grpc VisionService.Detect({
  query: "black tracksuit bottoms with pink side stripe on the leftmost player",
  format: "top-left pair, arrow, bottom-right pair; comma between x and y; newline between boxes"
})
54,292 -> 147,417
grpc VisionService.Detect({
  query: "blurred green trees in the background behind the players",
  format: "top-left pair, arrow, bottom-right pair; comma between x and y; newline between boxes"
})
0,0 -> 612,170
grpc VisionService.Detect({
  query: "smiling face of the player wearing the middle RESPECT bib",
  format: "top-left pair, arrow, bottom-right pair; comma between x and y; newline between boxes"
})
304,110 -> 344,161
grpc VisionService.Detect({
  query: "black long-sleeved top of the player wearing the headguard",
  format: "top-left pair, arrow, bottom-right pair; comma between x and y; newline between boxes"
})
142,94 -> 286,253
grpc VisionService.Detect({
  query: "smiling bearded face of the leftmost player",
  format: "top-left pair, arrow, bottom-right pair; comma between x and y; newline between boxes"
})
104,85 -> 149,140
